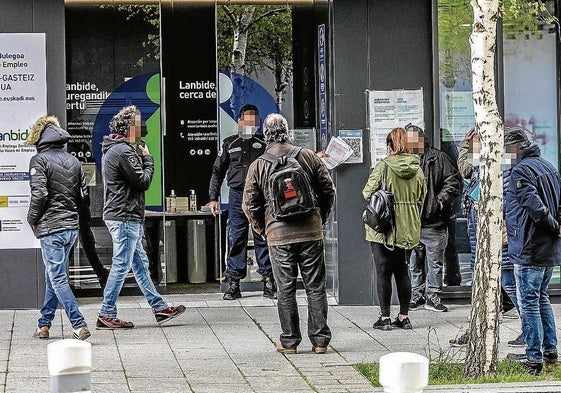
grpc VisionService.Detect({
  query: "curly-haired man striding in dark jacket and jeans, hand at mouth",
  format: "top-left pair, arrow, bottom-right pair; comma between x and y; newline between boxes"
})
96,105 -> 185,330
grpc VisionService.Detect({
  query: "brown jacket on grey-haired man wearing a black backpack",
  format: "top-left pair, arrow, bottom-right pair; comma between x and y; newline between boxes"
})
242,143 -> 335,246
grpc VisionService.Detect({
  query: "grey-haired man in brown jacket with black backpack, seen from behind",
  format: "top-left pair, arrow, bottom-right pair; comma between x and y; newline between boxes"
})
242,114 -> 335,354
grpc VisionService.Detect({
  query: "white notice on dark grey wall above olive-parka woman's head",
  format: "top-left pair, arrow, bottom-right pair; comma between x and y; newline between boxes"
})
367,89 -> 425,167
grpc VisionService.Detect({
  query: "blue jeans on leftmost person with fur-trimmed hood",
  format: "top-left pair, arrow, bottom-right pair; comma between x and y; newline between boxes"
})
38,229 -> 87,329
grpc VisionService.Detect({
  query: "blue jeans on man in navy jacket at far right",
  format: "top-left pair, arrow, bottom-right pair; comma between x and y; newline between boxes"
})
514,265 -> 557,363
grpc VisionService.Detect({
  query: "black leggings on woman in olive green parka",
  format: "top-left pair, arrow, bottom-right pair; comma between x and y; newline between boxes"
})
370,242 -> 411,317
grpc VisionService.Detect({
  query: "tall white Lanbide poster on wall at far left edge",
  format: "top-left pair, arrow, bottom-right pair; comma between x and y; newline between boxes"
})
0,33 -> 47,249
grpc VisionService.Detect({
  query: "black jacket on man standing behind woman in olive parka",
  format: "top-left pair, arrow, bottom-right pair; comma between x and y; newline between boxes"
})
421,147 -> 462,228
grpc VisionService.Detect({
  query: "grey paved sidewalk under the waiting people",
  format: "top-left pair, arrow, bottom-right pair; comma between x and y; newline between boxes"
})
0,291 -> 561,393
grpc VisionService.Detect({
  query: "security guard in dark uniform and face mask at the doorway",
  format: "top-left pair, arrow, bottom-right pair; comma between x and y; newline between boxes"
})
207,104 -> 277,300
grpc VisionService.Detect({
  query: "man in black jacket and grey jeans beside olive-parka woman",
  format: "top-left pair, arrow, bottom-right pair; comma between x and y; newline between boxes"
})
405,124 -> 461,312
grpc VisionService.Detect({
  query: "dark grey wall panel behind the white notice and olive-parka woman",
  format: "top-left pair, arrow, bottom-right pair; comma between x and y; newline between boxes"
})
333,0 -> 433,304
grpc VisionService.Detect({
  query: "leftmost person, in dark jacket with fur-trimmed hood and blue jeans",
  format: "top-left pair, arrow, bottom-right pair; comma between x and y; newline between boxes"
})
25,116 -> 90,340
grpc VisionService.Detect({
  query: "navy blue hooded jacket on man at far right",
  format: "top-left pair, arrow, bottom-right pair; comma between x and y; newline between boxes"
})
505,145 -> 561,267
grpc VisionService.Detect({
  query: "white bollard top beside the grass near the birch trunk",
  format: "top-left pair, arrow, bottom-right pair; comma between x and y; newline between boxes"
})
378,352 -> 429,393
